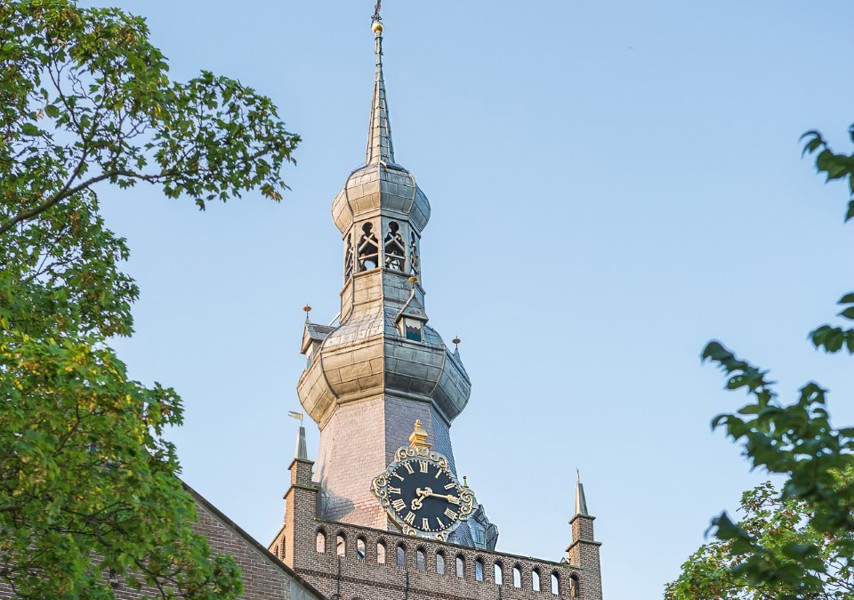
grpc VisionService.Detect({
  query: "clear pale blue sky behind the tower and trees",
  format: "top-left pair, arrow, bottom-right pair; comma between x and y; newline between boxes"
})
85,0 -> 854,600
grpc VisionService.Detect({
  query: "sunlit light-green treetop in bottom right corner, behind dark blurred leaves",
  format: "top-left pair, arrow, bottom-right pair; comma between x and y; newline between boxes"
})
665,472 -> 854,600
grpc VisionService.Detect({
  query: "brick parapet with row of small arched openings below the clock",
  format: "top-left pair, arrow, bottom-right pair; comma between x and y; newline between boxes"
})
270,461 -> 602,600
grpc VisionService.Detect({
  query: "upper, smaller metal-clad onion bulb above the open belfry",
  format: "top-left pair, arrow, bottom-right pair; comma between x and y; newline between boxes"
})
332,164 -> 430,235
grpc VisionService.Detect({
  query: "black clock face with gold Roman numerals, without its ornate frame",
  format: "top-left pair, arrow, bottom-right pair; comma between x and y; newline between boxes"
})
387,457 -> 460,533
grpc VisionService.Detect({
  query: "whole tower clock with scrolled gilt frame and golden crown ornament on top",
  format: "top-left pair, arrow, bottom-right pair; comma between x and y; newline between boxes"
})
371,421 -> 475,542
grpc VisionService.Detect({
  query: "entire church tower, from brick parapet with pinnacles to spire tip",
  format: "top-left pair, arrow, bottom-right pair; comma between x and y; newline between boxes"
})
269,10 -> 602,600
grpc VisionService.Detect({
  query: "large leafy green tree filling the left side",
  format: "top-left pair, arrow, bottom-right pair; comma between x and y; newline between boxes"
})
0,0 -> 299,599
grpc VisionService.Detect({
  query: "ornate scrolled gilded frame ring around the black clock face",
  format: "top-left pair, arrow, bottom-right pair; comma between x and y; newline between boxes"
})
371,446 -> 475,542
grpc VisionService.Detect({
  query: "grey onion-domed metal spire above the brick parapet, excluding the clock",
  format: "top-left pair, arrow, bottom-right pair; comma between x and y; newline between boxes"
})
297,19 -> 484,546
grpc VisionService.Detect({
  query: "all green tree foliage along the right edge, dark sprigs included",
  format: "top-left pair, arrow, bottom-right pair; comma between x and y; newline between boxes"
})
667,126 -> 854,600
